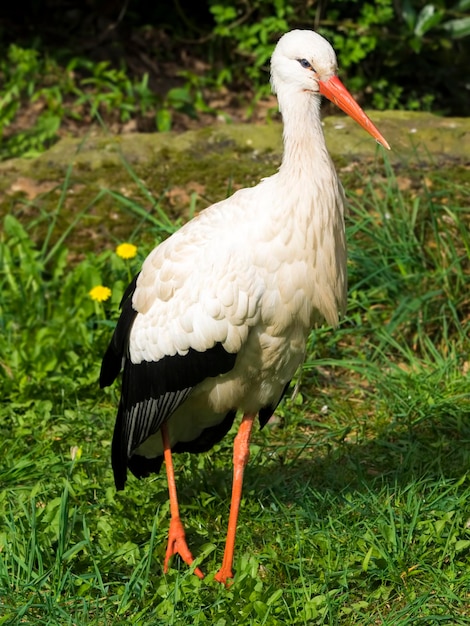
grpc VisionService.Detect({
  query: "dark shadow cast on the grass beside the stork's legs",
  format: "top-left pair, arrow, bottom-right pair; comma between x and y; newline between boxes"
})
144,410 -> 470,553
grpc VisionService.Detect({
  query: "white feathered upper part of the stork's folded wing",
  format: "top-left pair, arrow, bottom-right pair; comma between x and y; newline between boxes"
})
130,195 -> 266,363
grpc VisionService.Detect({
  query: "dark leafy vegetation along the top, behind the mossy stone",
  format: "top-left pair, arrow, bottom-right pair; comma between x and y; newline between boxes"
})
0,0 -> 470,158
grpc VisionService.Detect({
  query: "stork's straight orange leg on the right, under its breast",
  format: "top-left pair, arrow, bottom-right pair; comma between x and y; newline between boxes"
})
215,415 -> 255,584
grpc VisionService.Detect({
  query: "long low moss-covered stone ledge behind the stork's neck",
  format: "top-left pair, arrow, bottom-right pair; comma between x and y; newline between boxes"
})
0,112 -> 470,252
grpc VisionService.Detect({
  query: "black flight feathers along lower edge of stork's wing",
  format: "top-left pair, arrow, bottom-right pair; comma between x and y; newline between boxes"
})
100,276 -> 237,489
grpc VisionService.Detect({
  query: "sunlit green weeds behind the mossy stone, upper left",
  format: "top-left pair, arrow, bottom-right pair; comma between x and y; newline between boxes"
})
0,43 -> 204,160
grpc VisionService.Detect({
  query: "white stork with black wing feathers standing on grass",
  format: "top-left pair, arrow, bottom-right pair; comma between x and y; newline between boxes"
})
100,30 -> 389,584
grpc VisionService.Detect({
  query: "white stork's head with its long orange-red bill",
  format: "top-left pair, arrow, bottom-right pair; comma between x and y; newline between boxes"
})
271,30 -> 390,149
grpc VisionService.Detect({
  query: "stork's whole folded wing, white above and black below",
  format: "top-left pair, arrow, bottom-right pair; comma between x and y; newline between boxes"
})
100,190 -> 263,489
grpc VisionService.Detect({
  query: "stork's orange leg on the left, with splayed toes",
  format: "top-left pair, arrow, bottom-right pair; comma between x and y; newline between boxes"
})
161,424 -> 204,578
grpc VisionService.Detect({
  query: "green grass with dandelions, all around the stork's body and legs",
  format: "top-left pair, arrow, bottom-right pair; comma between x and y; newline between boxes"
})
0,149 -> 470,626
